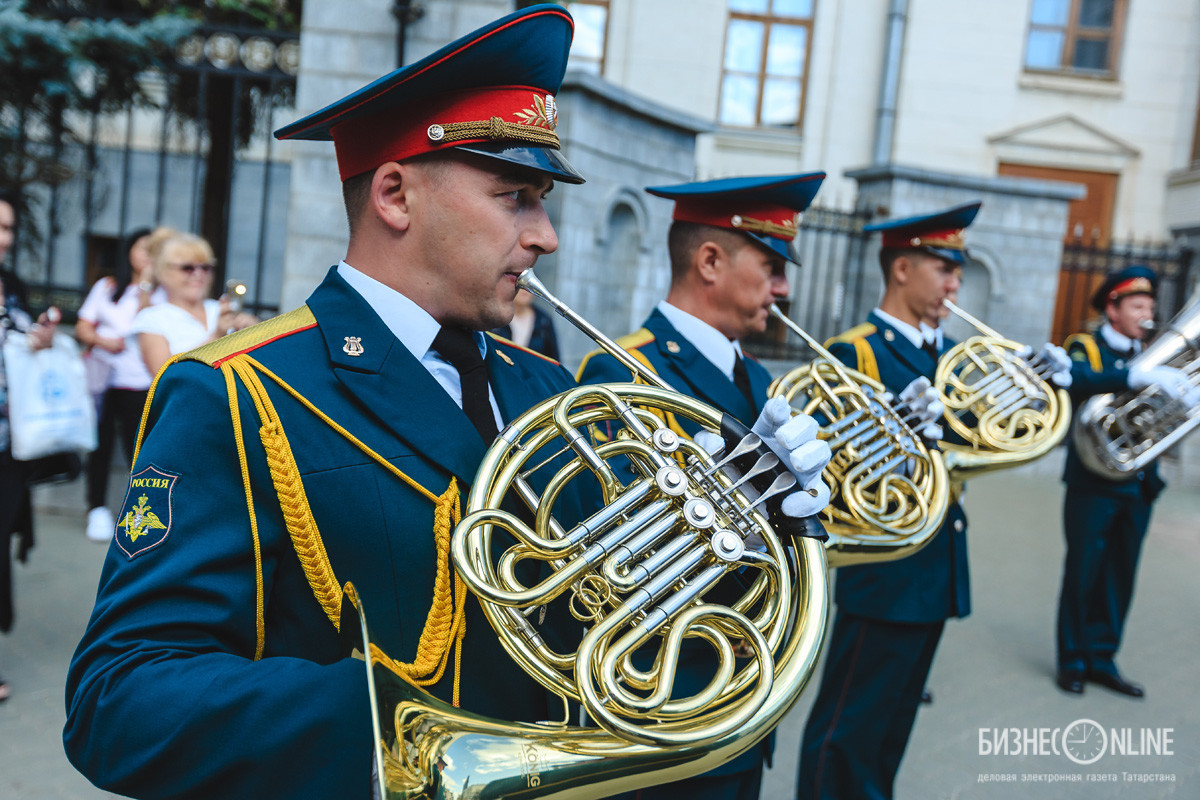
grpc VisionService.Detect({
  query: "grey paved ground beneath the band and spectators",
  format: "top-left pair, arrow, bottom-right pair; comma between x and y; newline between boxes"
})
7,450 -> 1200,800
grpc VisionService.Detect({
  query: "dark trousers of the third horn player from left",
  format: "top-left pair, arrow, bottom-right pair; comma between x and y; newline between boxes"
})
796,612 -> 946,800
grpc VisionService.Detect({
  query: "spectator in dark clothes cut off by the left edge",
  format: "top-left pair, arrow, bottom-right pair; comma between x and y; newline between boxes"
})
0,190 -> 58,702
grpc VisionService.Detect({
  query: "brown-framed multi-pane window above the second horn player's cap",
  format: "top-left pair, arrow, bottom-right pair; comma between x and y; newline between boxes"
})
719,0 -> 814,127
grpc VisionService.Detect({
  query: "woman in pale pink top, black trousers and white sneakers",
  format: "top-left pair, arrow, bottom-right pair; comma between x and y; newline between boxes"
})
76,228 -> 166,542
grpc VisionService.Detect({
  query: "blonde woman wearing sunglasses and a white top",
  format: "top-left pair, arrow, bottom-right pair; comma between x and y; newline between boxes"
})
133,234 -> 257,375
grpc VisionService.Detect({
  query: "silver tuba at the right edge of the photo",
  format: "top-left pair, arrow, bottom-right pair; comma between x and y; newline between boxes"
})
1074,291 -> 1200,481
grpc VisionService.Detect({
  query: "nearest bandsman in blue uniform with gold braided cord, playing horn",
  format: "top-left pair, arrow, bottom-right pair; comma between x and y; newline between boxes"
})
64,5 -> 828,799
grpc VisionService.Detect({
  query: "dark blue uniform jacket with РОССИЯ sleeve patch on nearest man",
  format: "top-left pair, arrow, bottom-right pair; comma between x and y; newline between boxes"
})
64,270 -> 587,799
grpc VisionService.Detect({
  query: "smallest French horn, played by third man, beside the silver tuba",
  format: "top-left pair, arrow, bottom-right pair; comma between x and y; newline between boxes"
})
934,300 -> 1070,481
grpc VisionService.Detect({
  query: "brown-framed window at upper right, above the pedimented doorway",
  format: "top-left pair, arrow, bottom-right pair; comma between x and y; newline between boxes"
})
1025,0 -> 1127,78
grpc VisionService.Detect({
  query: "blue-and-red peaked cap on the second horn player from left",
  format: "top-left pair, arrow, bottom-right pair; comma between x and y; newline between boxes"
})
646,173 -> 824,264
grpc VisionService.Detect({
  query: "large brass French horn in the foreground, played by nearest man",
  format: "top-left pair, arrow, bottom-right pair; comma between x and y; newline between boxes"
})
360,271 -> 829,800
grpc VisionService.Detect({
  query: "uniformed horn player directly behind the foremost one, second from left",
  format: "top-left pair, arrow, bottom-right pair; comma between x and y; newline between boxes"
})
578,173 -> 941,800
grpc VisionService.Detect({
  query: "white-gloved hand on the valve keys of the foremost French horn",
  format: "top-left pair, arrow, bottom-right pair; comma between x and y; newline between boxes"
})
695,397 -> 833,517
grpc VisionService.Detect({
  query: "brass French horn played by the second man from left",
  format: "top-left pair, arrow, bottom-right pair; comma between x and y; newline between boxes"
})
768,303 -> 949,566
